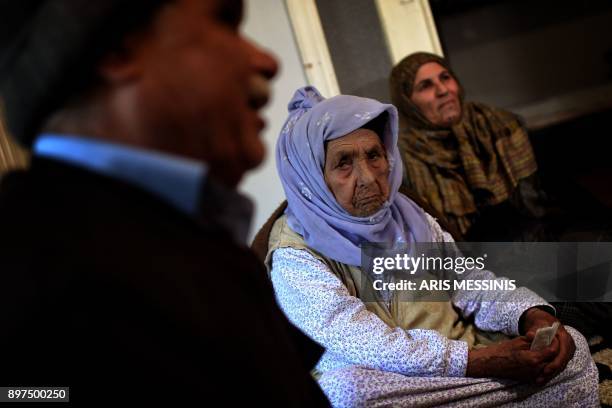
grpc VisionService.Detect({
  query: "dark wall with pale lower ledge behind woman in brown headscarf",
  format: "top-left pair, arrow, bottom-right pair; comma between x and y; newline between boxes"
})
433,0 -> 612,128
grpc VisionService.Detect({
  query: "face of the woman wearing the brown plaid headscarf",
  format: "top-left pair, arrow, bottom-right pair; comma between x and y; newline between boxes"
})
410,62 -> 461,126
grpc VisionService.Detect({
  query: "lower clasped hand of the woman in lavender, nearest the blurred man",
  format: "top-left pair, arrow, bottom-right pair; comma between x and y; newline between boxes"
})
466,333 -> 559,383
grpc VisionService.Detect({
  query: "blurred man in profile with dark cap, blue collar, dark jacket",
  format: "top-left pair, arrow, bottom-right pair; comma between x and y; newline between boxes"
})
0,0 -> 327,406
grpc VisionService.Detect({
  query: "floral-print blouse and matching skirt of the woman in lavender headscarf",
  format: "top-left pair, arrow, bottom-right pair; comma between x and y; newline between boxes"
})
271,215 -> 598,407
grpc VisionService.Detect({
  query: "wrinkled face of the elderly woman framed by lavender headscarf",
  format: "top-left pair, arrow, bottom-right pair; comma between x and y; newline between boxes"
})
324,129 -> 389,217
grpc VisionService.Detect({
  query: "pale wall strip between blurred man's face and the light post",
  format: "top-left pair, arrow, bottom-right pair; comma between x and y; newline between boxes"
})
240,0 -> 306,240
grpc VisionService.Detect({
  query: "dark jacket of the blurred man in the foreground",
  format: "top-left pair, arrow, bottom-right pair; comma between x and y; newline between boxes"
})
0,158 -> 327,407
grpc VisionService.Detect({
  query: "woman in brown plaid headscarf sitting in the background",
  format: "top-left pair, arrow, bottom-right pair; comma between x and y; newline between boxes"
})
390,52 -> 549,241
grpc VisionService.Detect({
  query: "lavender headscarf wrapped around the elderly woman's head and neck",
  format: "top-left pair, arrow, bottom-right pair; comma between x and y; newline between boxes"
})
276,86 -> 431,266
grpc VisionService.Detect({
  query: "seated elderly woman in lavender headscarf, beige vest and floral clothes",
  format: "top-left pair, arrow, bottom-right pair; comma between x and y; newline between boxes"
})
266,87 -> 598,407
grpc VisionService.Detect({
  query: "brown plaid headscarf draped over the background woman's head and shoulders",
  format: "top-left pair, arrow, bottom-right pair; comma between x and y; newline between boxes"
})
390,52 -> 537,234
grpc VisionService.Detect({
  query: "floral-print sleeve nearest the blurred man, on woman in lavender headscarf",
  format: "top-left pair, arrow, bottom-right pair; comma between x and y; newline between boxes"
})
272,248 -> 468,377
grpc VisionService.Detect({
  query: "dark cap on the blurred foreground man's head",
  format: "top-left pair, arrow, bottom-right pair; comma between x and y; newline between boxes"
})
0,0 -> 164,146
